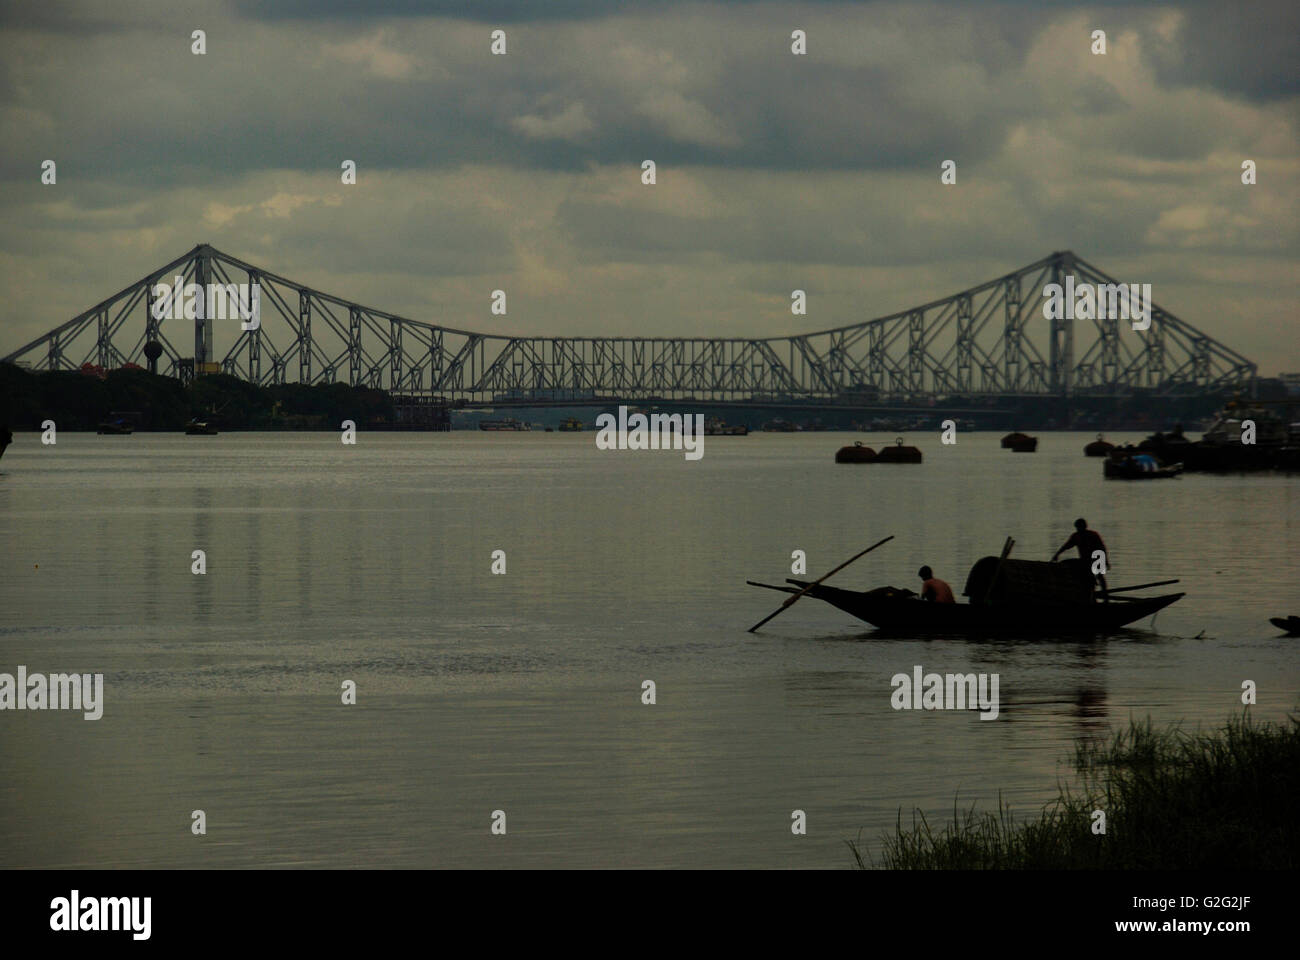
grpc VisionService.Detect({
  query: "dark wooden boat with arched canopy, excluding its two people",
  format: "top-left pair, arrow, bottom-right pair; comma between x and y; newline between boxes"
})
750,548 -> 1184,635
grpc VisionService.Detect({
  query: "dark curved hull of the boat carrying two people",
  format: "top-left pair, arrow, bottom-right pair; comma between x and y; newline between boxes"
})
787,580 -> 1184,635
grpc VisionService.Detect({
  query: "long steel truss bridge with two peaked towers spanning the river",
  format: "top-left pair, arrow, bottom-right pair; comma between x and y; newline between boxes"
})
4,243 -> 1256,406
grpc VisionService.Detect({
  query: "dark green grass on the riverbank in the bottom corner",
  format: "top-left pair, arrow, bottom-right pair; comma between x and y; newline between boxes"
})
849,714 -> 1300,870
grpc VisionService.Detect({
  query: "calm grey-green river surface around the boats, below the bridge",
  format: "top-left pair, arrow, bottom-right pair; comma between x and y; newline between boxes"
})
0,432 -> 1300,868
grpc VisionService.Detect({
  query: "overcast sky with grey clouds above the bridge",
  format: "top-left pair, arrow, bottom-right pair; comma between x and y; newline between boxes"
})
0,0 -> 1300,376
